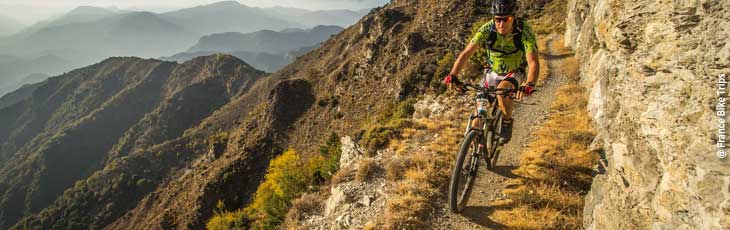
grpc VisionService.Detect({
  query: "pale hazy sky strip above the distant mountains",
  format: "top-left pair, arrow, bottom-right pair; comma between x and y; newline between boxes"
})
0,0 -> 389,24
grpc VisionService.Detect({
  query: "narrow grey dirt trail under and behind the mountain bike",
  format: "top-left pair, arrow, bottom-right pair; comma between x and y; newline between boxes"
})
434,35 -> 565,229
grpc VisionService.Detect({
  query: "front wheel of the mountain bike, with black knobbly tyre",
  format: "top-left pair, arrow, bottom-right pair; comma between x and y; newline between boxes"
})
449,130 -> 483,213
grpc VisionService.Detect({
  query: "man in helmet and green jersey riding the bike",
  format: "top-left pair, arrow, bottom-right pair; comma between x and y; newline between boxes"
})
444,0 -> 540,143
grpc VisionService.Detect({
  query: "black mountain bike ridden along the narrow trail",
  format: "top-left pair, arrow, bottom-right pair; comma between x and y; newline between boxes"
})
449,83 -> 517,213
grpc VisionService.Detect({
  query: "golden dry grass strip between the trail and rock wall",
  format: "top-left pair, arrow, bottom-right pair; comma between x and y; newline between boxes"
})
490,37 -> 598,229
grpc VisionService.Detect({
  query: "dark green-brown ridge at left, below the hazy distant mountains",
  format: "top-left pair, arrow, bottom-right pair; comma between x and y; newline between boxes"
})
0,55 -> 263,228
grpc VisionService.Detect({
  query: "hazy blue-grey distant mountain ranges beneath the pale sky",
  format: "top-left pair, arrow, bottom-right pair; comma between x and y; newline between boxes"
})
0,1 -> 365,96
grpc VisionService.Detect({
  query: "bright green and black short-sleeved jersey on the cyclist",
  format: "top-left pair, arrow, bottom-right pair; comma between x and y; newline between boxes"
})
471,20 -> 538,74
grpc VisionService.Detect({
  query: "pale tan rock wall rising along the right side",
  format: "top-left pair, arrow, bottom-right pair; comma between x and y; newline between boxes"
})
565,0 -> 730,229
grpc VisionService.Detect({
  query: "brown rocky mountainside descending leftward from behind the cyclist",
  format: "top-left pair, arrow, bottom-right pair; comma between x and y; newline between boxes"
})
9,1 -> 486,229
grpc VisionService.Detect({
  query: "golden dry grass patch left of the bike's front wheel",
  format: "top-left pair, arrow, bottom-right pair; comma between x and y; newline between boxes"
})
378,119 -> 461,229
